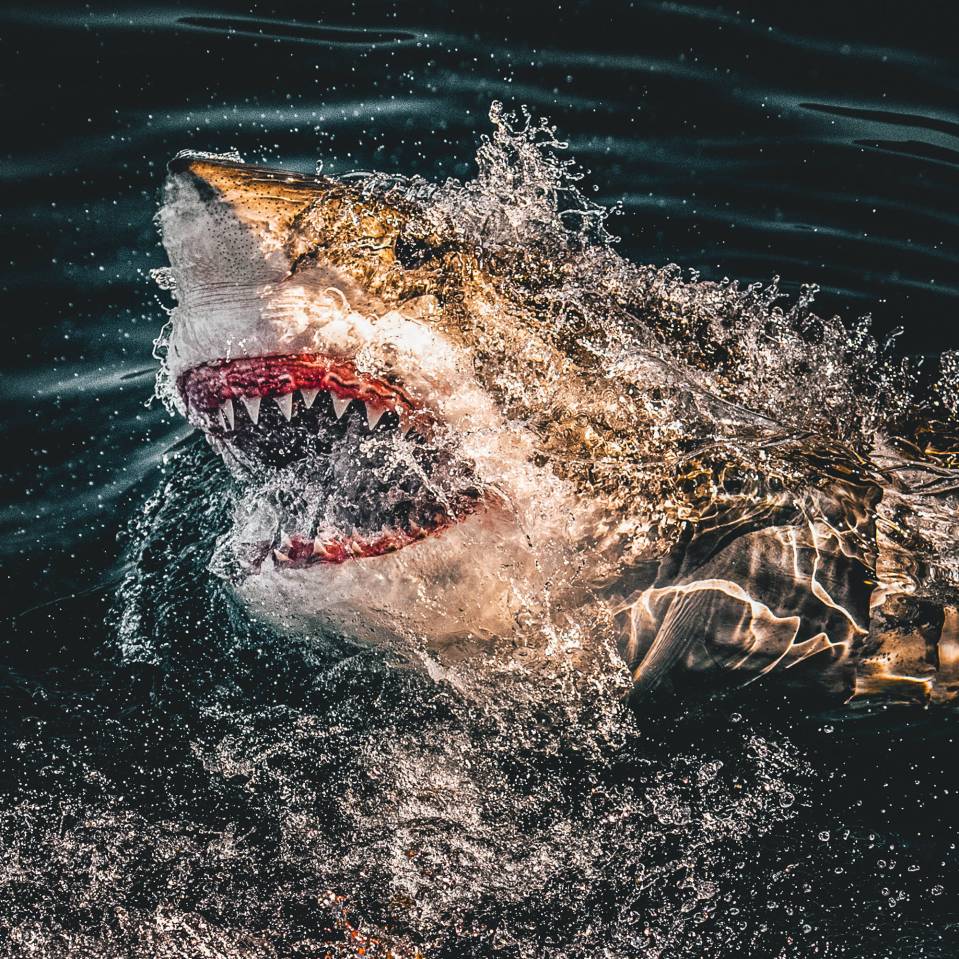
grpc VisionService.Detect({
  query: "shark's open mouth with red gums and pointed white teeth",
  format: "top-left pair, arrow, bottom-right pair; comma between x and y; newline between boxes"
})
178,354 -> 482,568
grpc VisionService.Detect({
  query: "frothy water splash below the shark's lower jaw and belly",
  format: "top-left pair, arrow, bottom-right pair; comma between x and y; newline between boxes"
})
0,432 -> 809,957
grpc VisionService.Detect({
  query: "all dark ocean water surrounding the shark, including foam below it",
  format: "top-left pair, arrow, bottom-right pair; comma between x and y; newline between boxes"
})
0,2 -> 959,957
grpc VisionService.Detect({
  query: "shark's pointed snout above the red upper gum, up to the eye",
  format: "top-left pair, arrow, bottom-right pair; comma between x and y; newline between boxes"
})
161,154 -> 492,419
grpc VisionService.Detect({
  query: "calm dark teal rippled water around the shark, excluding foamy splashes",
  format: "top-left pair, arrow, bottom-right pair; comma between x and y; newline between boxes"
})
0,2 -> 959,956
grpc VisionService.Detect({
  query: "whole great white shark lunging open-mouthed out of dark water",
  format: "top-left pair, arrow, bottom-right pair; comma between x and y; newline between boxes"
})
159,129 -> 959,702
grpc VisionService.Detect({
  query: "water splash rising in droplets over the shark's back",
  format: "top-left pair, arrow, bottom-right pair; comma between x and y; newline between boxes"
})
365,102 -> 944,445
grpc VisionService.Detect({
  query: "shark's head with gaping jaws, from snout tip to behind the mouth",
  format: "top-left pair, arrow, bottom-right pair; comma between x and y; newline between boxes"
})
160,155 -> 637,664
